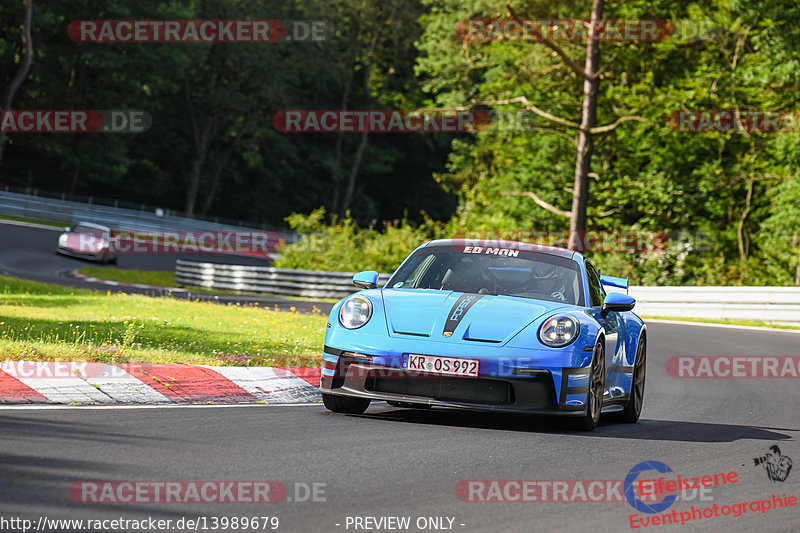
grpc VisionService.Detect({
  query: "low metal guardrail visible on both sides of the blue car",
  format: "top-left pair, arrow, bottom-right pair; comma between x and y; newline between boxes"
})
175,260 -> 800,324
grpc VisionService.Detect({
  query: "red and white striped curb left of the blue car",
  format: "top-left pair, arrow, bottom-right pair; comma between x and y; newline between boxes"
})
0,361 -> 321,405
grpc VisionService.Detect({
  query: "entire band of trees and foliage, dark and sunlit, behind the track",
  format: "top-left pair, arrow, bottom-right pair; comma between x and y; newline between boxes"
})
0,0 -> 800,285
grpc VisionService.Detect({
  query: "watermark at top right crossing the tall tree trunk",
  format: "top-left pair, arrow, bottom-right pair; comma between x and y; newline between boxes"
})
456,18 -> 674,42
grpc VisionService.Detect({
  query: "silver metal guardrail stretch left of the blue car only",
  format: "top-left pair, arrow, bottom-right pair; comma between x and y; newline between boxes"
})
175,259 -> 389,298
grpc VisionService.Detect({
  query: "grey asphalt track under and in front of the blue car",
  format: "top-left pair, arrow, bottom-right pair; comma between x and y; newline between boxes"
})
0,323 -> 800,532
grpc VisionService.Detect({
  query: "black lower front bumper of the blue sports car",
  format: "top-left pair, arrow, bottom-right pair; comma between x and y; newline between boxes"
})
320,349 -> 588,416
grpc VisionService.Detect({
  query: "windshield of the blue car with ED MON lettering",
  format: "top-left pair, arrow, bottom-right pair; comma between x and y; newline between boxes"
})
387,246 -> 583,305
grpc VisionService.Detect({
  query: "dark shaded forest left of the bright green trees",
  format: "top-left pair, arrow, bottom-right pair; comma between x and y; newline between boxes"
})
0,0 -> 455,226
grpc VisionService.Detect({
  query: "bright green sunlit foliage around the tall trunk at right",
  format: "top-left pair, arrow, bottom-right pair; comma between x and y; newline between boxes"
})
418,0 -> 800,284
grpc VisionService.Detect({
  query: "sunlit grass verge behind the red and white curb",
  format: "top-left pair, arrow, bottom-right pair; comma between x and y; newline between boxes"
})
0,276 -> 327,367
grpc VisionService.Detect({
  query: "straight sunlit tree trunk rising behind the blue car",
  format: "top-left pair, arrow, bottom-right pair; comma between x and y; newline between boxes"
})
569,0 -> 605,250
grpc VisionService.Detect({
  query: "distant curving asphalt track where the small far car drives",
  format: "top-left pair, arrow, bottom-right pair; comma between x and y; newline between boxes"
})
0,221 -> 330,312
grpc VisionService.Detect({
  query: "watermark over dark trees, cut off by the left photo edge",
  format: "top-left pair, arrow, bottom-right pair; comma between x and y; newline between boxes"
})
0,109 -> 153,133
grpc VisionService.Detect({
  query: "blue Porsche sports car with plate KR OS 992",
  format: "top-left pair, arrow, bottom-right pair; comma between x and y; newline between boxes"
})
320,239 -> 647,431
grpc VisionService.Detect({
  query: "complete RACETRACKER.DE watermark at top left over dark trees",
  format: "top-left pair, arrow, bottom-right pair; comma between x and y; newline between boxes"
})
67,20 -> 333,44
